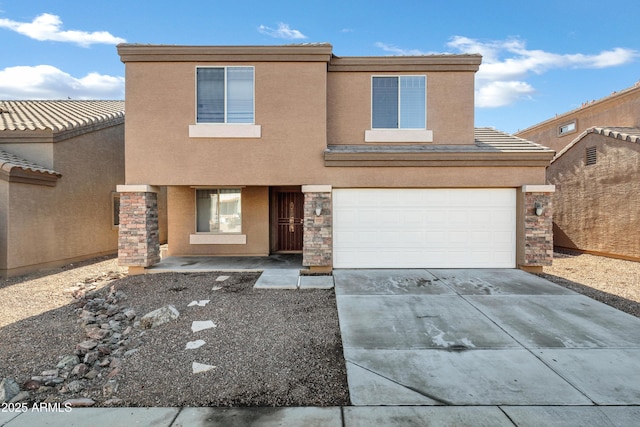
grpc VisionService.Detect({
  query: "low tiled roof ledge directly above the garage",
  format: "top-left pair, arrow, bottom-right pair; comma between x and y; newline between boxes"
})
324,128 -> 554,167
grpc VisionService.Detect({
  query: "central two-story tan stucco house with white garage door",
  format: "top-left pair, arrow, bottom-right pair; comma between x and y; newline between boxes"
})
118,44 -> 554,272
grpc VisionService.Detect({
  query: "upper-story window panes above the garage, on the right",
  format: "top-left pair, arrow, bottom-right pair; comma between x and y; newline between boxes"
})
371,76 -> 427,129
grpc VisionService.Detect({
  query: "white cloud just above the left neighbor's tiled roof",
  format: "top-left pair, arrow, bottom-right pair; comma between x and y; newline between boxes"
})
0,65 -> 124,99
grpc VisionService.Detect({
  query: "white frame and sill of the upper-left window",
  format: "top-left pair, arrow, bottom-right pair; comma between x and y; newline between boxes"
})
189,65 -> 262,138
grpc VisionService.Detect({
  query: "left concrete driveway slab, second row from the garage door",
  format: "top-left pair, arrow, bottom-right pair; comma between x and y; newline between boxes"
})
337,295 -> 520,350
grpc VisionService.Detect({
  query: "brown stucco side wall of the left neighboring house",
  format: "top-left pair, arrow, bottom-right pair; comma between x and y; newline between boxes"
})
2,125 -> 124,275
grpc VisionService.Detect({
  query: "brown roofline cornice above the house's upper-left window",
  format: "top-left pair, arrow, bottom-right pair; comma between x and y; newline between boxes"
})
117,43 -> 333,63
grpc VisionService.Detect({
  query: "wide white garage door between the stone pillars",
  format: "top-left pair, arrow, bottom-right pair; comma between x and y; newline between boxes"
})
333,189 -> 516,268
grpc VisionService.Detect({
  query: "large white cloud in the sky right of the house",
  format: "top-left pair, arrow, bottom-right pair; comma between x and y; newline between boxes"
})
447,36 -> 640,107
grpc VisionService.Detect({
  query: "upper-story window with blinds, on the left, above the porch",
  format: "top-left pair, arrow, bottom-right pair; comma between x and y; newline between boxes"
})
196,67 -> 254,123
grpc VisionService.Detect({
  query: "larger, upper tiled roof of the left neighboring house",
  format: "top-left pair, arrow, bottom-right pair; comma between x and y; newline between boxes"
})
0,100 -> 124,142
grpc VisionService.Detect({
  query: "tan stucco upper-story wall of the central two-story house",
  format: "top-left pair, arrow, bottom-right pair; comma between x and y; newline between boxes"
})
126,62 -> 544,187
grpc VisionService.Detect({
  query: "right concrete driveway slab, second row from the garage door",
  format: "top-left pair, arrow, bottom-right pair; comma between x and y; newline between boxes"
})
466,294 -> 640,348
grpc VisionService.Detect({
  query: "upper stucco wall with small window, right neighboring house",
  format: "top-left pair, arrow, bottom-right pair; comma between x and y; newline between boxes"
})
516,85 -> 640,152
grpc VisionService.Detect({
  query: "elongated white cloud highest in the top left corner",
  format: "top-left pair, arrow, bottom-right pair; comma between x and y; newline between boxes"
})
0,13 -> 126,47
